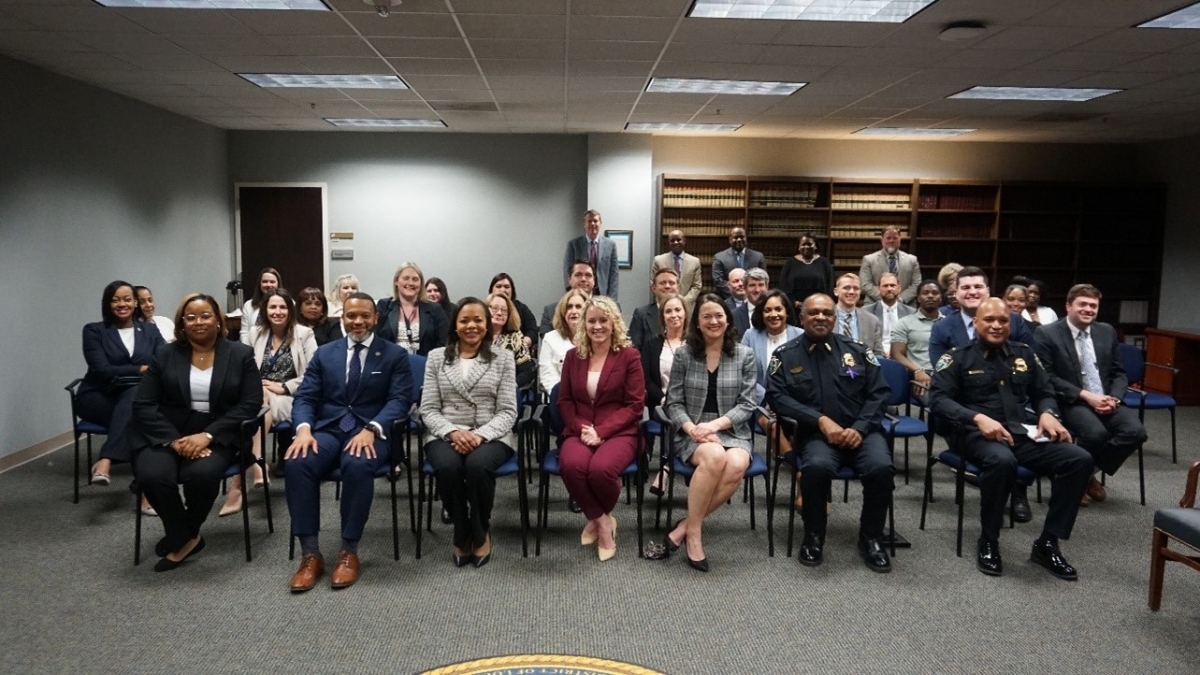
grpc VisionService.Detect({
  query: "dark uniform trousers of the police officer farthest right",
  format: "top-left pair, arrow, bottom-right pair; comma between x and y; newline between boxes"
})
959,430 -> 1092,542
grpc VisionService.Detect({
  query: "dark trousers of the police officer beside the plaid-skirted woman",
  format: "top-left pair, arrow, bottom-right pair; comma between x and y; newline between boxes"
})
800,434 -> 896,538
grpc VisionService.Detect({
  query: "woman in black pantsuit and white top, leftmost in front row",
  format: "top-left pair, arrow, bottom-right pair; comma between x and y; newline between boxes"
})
131,293 -> 263,572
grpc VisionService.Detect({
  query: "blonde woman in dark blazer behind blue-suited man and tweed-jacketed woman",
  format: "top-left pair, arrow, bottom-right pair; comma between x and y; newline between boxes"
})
376,263 -> 450,357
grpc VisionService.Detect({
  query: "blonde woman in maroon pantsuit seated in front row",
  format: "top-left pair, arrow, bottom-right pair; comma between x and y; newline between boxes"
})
558,295 -> 646,561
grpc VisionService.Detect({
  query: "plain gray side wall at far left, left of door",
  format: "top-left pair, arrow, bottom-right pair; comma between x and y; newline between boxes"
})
0,58 -> 232,456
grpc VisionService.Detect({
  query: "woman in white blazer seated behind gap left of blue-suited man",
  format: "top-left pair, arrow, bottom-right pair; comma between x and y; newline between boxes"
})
221,288 -> 317,515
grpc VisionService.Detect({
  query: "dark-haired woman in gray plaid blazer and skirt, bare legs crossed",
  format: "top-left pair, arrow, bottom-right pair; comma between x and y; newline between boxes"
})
664,293 -> 755,572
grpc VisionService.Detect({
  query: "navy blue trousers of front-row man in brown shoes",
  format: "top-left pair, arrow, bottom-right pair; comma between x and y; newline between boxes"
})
283,430 -> 389,542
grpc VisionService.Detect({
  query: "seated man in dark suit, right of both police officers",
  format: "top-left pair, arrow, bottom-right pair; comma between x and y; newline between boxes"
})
1037,283 -> 1146,506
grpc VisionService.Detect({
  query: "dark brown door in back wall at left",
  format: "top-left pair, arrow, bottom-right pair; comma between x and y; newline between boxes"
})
238,185 -> 325,300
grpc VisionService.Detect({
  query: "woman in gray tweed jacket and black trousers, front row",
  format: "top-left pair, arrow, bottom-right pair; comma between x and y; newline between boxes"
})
421,298 -> 517,567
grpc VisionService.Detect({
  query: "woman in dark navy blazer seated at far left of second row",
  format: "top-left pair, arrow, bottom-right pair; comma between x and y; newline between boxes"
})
76,280 -> 163,485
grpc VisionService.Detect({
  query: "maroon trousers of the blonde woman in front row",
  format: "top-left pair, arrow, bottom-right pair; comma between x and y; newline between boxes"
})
559,436 -> 637,520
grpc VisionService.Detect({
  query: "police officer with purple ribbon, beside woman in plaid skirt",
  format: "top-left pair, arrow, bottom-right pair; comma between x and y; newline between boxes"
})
767,293 -> 895,572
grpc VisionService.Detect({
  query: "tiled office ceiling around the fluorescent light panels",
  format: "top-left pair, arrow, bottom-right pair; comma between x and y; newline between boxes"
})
0,0 -> 1200,143
